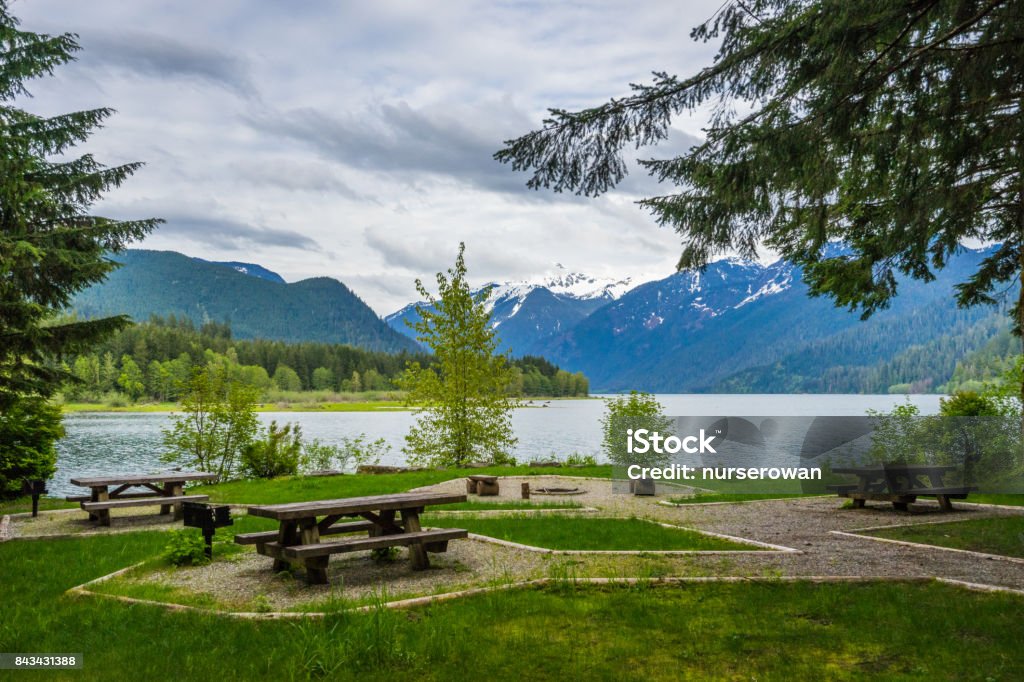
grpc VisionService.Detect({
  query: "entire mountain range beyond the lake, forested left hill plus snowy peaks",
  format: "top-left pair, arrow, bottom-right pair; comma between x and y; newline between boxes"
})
73,250 -> 1015,393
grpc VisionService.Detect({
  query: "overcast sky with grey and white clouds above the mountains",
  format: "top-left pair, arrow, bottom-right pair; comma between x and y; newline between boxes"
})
10,0 -> 722,314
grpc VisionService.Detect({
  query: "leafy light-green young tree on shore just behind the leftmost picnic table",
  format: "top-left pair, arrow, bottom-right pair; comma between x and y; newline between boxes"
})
162,367 -> 259,479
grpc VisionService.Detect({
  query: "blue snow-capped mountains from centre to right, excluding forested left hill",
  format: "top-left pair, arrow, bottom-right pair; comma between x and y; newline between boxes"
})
385,250 -> 1006,392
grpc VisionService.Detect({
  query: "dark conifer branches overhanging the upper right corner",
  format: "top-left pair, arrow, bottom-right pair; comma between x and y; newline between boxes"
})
496,0 -> 1024,395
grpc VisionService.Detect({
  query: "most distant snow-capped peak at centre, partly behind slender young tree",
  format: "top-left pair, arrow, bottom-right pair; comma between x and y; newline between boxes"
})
384,263 -> 638,355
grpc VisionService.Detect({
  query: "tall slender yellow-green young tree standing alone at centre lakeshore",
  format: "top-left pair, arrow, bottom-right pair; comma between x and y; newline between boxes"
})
400,244 -> 517,466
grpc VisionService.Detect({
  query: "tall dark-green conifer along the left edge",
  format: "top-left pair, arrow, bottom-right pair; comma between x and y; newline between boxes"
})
0,0 -> 159,495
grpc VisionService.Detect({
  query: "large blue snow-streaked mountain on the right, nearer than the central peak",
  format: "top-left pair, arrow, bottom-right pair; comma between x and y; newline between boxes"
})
536,250 -> 993,392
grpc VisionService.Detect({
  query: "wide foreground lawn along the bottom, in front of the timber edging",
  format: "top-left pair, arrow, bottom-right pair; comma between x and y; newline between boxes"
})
0,532 -> 1024,681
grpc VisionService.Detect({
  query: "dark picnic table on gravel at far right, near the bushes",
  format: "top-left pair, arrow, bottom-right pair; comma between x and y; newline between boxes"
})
828,463 -> 977,511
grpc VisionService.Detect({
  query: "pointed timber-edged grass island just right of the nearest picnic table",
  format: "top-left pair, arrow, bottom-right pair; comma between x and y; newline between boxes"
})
424,514 -> 760,551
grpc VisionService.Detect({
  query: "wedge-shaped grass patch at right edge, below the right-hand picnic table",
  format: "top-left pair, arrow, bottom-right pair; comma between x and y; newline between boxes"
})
865,516 -> 1024,558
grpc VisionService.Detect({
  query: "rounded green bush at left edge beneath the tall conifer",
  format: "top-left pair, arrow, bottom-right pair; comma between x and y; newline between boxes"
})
0,398 -> 63,500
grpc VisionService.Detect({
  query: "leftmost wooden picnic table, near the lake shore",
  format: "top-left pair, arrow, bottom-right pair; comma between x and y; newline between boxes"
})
67,471 -> 217,525
